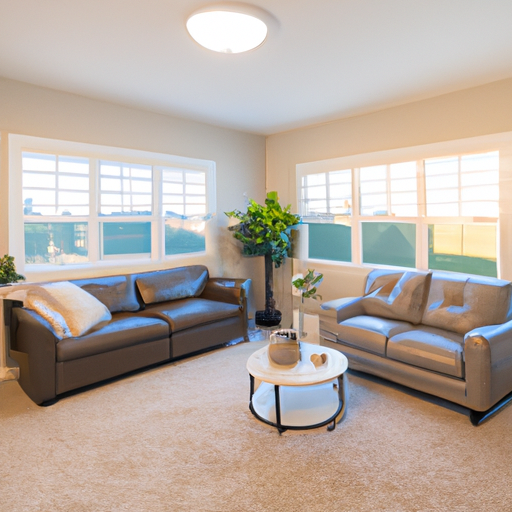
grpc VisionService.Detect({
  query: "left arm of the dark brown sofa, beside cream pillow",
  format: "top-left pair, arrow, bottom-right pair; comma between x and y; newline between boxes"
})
9,307 -> 58,405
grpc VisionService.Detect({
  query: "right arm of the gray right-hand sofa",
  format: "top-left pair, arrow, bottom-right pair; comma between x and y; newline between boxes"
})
464,321 -> 512,411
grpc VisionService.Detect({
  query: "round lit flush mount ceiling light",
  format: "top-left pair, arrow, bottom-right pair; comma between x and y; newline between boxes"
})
187,3 -> 269,53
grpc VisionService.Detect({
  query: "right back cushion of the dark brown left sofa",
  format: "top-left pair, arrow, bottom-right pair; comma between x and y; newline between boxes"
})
136,265 -> 208,304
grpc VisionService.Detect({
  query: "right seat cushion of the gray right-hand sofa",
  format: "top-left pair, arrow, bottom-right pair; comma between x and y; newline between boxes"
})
386,326 -> 464,379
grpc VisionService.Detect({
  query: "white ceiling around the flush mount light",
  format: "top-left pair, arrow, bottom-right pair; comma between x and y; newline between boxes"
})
0,0 -> 512,135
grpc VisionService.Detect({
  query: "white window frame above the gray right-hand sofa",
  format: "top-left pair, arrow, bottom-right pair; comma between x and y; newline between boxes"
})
296,132 -> 512,279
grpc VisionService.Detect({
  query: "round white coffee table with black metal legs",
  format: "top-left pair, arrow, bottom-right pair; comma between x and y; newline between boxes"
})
247,341 -> 348,434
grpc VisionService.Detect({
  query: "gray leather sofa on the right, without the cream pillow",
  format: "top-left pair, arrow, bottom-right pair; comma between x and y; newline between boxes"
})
321,270 -> 512,425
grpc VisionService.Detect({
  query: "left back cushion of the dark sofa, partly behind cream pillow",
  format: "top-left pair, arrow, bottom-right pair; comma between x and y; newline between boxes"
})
71,275 -> 140,313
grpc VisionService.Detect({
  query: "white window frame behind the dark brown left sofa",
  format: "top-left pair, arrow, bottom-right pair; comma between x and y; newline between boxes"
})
8,134 -> 217,274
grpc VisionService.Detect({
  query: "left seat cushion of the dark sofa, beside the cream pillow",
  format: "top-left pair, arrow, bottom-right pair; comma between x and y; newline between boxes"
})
57,313 -> 170,361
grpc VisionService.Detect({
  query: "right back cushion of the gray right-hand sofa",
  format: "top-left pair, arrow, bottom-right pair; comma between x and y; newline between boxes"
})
422,273 -> 511,334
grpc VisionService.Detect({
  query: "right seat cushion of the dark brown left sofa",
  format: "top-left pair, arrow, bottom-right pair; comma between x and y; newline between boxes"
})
142,298 -> 240,332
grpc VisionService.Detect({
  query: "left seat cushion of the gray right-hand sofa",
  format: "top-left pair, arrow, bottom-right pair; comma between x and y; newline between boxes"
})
337,315 -> 413,356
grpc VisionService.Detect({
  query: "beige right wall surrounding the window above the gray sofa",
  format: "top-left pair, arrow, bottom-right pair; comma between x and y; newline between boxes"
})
267,75 -> 512,312
